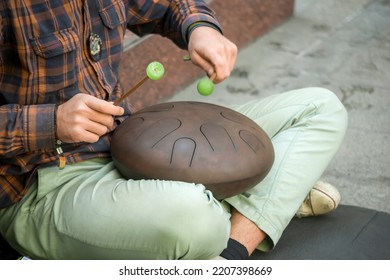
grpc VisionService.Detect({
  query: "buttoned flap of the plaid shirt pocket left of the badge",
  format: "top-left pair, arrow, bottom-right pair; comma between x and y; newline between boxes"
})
30,28 -> 79,58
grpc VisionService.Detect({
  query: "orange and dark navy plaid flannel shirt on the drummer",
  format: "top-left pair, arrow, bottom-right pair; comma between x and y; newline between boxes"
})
0,0 -> 219,208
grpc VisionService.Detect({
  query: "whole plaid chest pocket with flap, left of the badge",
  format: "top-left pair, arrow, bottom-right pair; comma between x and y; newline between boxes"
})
30,28 -> 81,94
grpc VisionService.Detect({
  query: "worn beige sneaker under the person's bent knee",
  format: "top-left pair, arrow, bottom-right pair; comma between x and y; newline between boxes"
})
295,181 -> 340,218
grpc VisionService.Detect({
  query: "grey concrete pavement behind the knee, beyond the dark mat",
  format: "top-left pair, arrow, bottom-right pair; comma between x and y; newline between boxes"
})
166,0 -> 390,213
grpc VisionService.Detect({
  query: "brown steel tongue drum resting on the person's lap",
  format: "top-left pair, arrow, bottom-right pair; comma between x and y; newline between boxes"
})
111,102 -> 274,199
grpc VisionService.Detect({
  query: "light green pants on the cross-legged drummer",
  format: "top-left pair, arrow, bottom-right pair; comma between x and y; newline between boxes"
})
0,88 -> 347,259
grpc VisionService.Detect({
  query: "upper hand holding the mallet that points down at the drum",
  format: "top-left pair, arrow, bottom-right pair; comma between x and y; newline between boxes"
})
188,26 -> 237,83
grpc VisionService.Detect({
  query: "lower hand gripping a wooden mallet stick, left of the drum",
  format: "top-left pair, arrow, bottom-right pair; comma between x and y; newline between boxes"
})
57,93 -> 124,143
